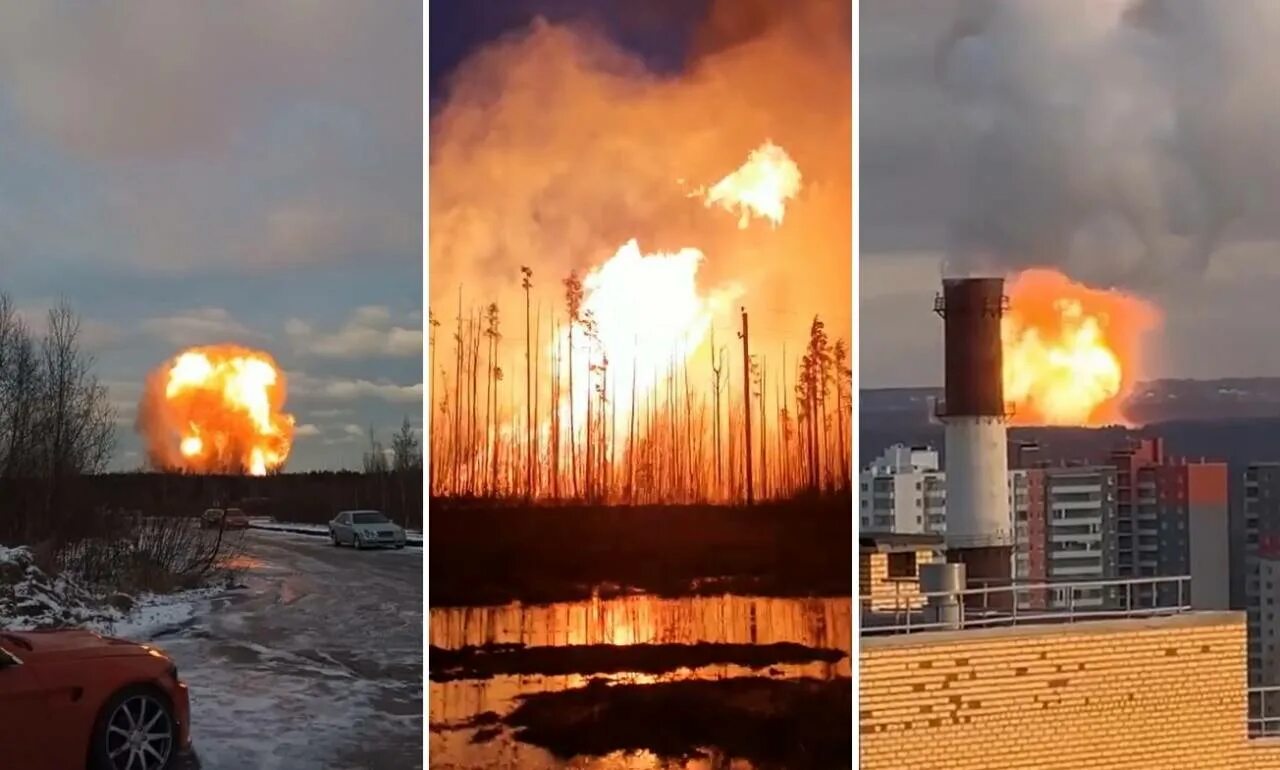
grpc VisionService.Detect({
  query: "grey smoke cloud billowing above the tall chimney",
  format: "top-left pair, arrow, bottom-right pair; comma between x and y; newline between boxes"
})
937,0 -> 1280,288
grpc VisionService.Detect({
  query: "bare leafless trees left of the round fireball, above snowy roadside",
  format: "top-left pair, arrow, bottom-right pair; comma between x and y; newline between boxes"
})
0,294 -> 115,541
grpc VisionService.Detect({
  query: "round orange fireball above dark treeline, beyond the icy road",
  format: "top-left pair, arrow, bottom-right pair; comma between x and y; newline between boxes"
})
137,344 -> 293,476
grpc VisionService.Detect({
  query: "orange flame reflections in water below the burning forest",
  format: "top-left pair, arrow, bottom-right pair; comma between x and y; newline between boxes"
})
429,596 -> 852,770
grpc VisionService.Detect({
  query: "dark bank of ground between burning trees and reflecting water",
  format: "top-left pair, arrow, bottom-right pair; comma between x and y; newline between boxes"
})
428,495 -> 854,606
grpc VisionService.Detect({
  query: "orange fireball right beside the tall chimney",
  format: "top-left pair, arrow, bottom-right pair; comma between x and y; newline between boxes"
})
1002,270 -> 1160,426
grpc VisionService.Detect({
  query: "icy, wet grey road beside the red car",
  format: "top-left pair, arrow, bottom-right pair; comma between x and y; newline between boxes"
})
147,532 -> 422,770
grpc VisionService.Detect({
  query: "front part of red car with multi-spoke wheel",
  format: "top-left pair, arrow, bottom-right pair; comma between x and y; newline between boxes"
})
0,629 -> 193,770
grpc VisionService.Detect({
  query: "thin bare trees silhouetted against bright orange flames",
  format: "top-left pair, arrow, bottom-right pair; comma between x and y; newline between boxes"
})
426,267 -> 852,504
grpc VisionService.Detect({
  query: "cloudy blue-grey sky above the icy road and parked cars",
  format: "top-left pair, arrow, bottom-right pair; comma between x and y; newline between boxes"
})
0,0 -> 422,469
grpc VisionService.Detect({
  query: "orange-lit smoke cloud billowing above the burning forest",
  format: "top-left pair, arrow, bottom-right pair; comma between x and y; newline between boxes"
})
429,0 -> 851,347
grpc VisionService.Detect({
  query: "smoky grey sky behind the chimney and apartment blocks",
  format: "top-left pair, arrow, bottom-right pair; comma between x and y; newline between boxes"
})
859,0 -> 1280,388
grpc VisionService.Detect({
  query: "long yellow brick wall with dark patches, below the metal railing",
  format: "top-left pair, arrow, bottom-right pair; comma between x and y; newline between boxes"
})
859,613 -> 1280,770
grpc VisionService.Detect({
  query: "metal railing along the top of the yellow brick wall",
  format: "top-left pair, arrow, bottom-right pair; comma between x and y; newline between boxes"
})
860,576 -> 1192,631
